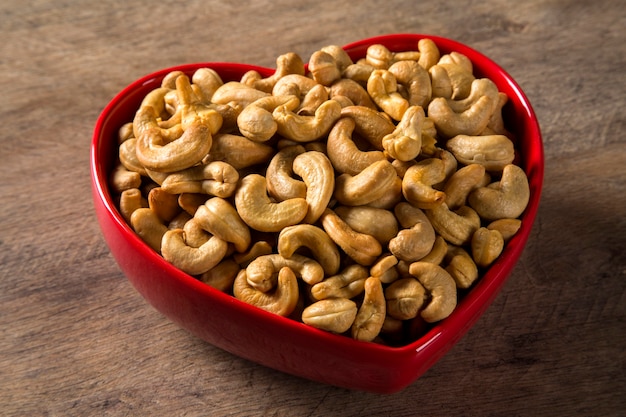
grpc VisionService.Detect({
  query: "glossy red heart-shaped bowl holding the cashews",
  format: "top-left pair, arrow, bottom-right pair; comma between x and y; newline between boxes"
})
90,34 -> 544,393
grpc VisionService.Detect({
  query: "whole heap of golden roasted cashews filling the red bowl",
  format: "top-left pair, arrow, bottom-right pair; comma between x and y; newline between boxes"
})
111,39 -> 529,344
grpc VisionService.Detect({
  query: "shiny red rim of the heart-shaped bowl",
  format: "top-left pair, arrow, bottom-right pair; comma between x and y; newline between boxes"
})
90,33 -> 544,362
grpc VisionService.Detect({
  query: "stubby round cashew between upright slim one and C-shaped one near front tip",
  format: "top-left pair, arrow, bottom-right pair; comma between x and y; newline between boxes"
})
385,277 -> 426,320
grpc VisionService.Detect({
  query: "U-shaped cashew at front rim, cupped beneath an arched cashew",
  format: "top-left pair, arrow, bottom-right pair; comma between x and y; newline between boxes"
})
233,267 -> 299,317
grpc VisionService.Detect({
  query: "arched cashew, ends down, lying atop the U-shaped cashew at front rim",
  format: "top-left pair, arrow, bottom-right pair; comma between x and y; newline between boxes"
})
246,253 -> 324,292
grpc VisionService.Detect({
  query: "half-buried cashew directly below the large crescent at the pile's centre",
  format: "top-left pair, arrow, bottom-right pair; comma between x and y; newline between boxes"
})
335,206 -> 398,245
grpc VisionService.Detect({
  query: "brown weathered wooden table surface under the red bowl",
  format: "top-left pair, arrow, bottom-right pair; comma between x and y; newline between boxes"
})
0,0 -> 626,416
